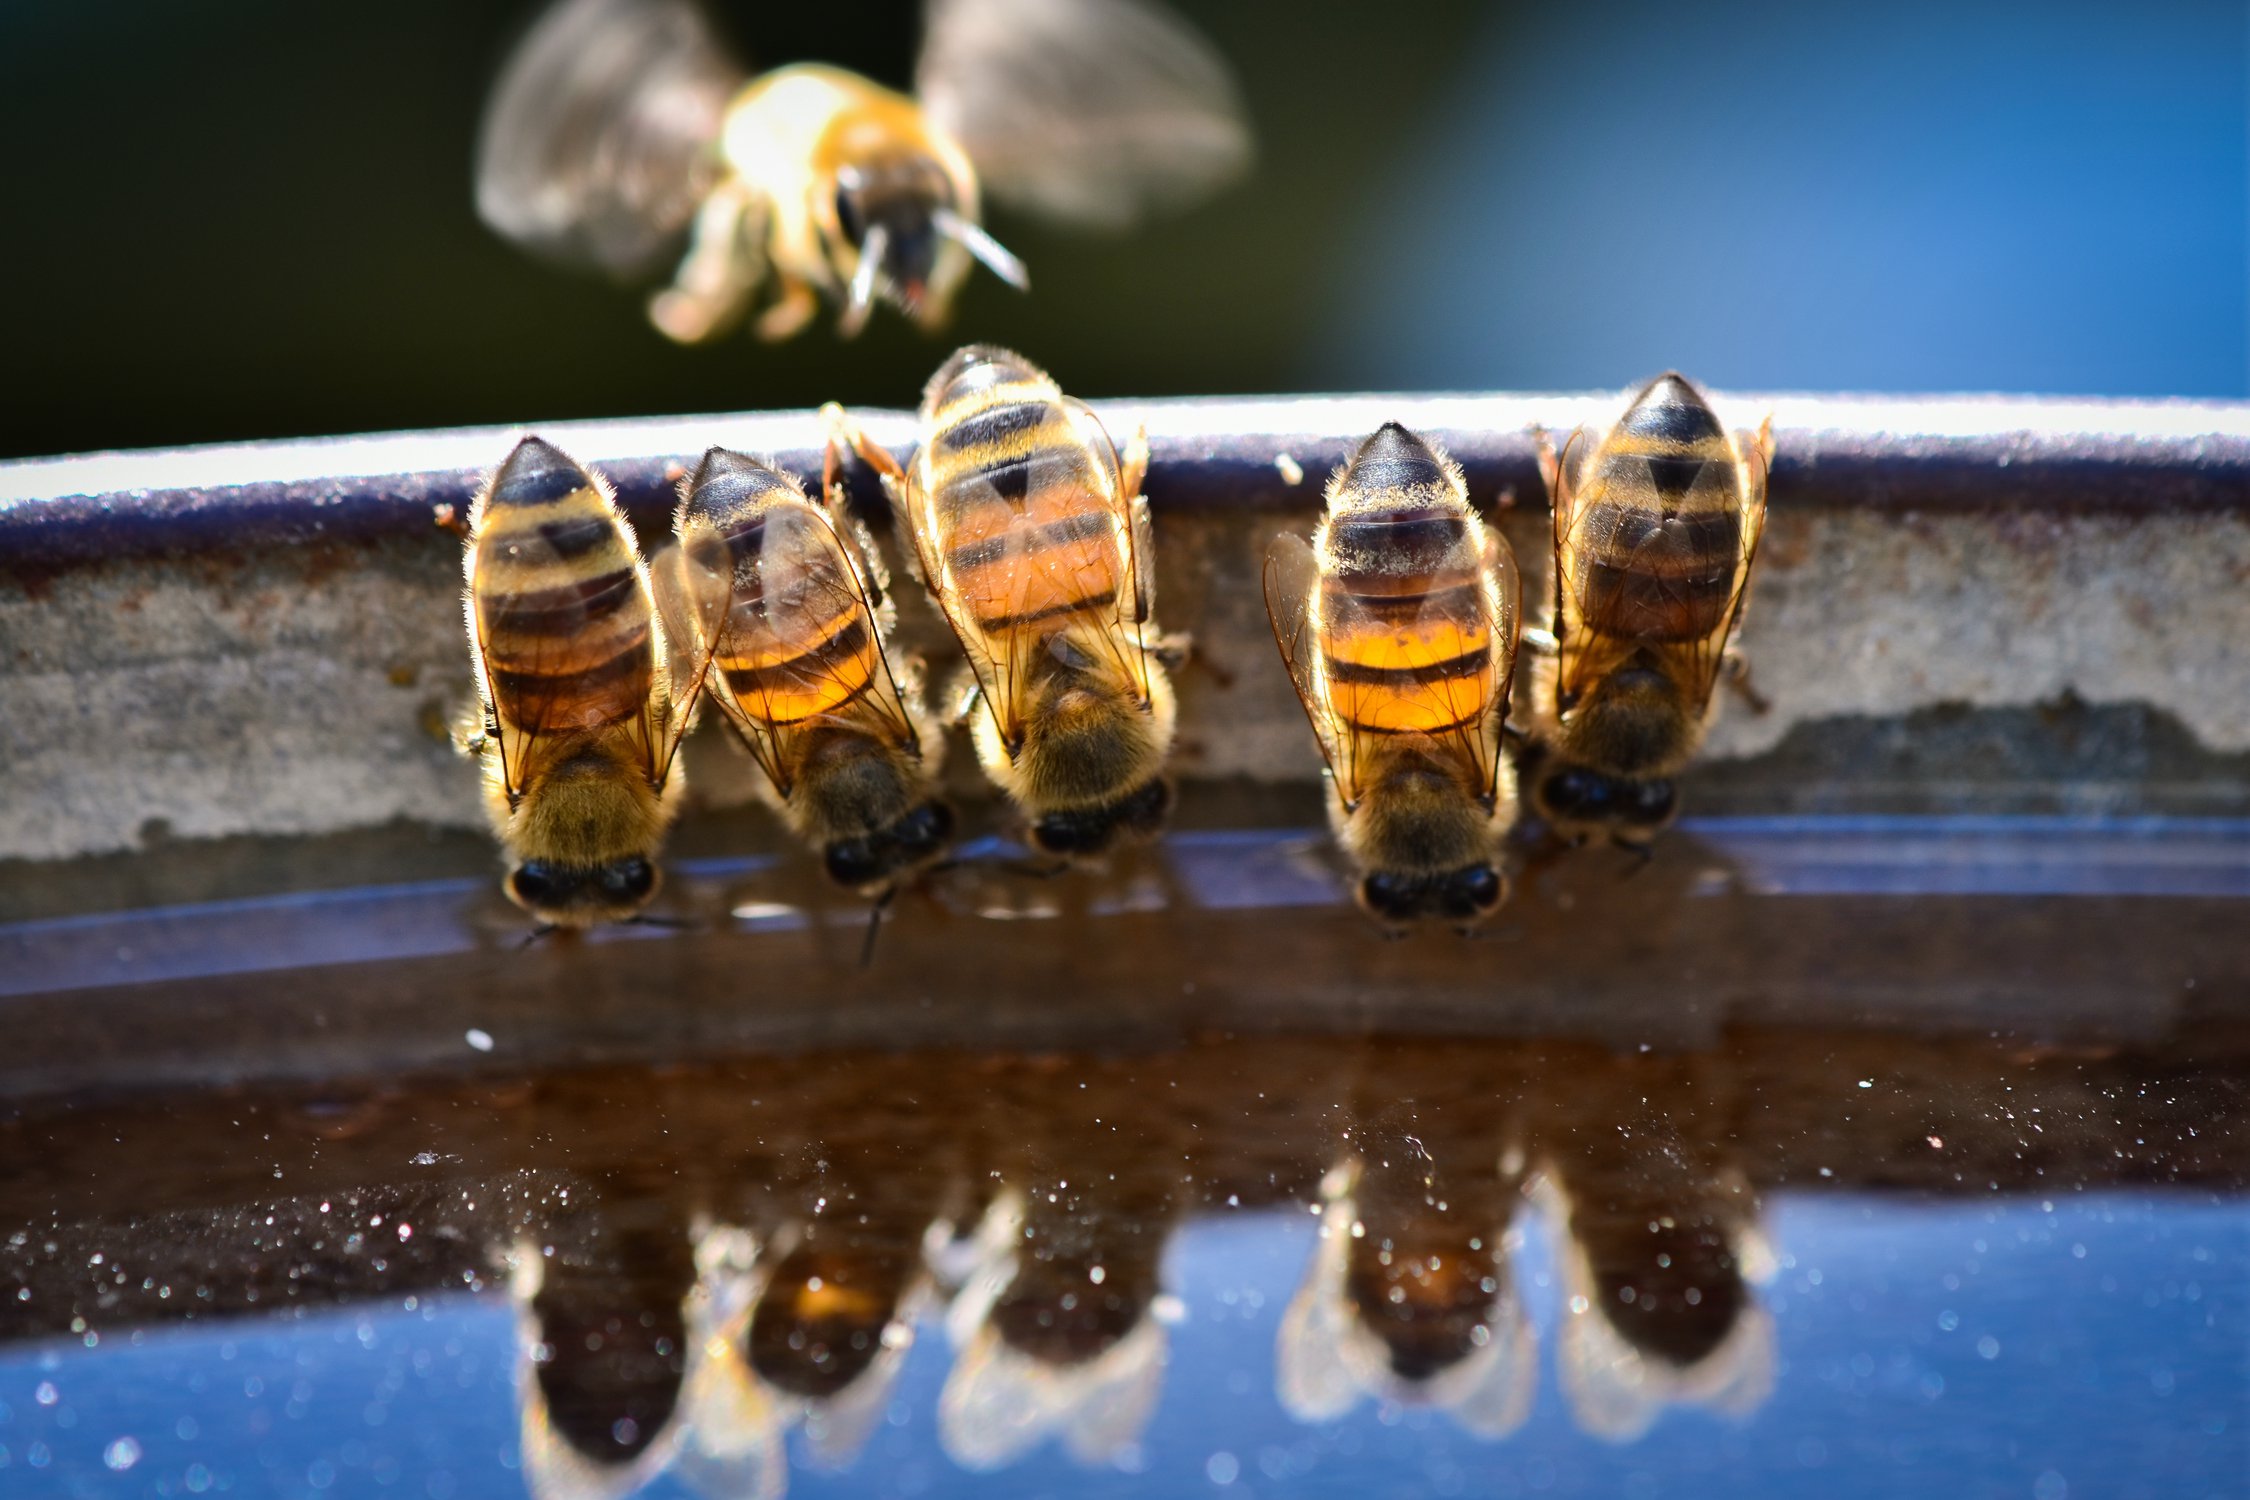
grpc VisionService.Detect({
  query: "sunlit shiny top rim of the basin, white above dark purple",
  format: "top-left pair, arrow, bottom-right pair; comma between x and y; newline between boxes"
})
0,394 -> 2250,571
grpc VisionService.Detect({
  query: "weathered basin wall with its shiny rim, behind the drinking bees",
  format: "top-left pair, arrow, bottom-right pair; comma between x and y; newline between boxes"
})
0,394 -> 2250,859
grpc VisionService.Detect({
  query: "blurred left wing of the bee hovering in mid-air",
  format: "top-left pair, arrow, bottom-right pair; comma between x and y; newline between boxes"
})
477,0 -> 745,277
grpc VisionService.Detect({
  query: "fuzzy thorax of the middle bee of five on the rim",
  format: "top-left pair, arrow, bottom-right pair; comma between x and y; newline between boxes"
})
974,661 -> 1179,816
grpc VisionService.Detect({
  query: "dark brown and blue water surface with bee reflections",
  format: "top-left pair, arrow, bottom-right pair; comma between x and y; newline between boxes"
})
0,819 -> 2250,1500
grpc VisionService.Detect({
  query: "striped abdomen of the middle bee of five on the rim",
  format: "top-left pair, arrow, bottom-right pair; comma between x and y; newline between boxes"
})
920,351 -> 1130,636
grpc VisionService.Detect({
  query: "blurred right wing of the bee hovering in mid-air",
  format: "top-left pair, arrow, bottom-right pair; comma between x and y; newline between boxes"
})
916,0 -> 1251,227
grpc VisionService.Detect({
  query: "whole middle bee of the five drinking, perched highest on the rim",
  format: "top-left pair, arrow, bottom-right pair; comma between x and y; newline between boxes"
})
828,344 -> 1184,859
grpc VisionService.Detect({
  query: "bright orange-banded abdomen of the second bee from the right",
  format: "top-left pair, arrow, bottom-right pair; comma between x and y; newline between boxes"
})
1314,425 -> 1494,733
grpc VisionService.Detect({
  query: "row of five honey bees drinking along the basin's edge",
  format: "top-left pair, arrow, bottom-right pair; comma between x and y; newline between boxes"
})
464,346 -> 1773,931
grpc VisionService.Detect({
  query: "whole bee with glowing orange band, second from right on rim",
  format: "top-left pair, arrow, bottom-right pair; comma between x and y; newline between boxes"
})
1265,423 -> 1521,931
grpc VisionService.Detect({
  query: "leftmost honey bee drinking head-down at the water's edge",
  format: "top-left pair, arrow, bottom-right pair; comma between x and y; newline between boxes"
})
464,439 -> 707,927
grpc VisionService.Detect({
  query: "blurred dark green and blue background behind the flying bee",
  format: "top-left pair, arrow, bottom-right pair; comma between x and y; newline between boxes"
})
0,0 -> 2250,457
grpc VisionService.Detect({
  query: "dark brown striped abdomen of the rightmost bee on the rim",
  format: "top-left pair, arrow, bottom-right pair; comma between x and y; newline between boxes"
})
1564,376 -> 1748,641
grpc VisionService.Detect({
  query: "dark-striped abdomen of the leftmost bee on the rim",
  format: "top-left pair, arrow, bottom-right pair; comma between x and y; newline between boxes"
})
468,439 -> 655,735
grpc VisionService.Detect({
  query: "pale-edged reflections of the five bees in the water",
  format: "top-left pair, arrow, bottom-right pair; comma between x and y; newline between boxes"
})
509,1160 -> 1775,1500
